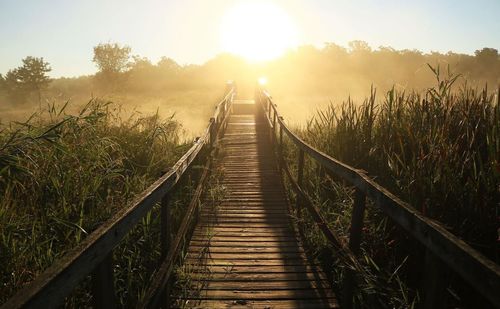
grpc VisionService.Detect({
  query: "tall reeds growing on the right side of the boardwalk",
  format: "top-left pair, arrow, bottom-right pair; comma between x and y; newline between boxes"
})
287,67 -> 500,307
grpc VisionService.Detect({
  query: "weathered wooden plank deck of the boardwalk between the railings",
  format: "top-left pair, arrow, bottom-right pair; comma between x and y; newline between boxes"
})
178,100 -> 337,309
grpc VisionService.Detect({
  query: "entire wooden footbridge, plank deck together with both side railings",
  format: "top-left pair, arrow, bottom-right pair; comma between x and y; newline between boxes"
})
4,84 -> 500,309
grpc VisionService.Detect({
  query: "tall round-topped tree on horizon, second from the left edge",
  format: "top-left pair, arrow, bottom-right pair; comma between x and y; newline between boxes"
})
92,43 -> 131,88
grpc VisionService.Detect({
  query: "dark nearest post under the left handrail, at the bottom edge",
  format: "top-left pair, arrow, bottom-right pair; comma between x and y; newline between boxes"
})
92,252 -> 116,309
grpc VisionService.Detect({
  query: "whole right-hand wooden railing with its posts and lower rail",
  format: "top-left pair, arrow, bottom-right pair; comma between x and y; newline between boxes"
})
256,89 -> 500,308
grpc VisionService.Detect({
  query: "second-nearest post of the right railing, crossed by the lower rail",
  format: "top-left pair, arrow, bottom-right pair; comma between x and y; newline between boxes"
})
343,188 -> 366,308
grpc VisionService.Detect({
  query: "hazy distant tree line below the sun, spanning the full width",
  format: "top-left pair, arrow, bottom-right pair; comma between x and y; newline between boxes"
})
0,41 -> 500,103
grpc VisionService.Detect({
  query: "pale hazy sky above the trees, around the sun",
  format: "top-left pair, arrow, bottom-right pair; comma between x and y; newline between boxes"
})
0,0 -> 500,77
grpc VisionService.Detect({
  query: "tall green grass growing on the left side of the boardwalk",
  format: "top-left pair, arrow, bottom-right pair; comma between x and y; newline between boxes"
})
0,100 -> 186,306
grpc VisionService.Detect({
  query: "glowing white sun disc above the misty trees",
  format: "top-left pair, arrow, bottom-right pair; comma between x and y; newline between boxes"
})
220,1 -> 297,61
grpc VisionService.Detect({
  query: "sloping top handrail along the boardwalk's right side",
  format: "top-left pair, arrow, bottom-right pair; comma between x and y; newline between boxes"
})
256,89 -> 500,308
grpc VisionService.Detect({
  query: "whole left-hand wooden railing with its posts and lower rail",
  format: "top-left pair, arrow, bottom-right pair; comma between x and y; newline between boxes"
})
2,83 -> 235,308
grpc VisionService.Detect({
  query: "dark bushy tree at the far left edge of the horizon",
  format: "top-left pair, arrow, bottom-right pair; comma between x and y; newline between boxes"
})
3,56 -> 52,103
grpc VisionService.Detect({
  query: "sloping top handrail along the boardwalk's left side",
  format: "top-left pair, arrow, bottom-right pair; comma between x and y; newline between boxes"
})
1,85 -> 235,308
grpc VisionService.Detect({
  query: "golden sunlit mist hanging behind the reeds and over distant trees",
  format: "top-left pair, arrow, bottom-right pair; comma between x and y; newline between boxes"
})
0,41 -> 500,136
